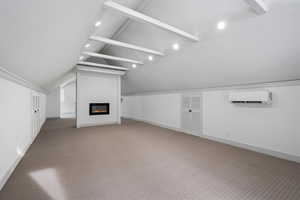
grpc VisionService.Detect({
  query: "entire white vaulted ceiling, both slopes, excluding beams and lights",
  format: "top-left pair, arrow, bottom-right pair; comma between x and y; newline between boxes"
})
0,0 -> 300,94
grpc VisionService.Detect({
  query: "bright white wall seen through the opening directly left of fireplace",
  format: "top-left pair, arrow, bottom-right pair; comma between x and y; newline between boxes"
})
60,82 -> 76,117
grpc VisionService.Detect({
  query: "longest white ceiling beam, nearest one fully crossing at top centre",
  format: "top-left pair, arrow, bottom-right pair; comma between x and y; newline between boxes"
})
104,1 -> 199,42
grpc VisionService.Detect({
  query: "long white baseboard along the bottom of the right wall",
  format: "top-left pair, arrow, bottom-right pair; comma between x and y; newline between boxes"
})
124,117 -> 300,163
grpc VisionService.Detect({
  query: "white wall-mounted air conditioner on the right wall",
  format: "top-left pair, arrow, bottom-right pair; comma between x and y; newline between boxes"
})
229,90 -> 272,104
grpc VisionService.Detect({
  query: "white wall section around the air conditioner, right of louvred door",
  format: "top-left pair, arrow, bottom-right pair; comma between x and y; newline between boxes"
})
203,86 -> 300,159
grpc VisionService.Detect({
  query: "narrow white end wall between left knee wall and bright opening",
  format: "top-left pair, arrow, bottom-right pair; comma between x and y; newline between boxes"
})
46,87 -> 60,118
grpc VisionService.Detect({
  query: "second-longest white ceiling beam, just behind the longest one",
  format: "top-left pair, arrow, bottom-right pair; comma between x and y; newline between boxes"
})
89,36 -> 164,56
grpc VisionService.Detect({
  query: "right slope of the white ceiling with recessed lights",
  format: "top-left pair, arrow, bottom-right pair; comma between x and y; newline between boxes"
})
103,0 -> 300,94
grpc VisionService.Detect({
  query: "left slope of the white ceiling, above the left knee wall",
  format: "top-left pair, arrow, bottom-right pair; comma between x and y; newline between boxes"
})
0,0 -> 140,90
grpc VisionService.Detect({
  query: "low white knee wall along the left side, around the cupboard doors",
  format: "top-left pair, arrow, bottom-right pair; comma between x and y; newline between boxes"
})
0,78 -> 46,190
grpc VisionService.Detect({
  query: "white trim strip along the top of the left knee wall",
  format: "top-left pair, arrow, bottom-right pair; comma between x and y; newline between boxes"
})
0,67 -> 45,93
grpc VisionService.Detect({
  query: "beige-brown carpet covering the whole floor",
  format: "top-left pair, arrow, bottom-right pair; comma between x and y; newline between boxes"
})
0,120 -> 300,200
